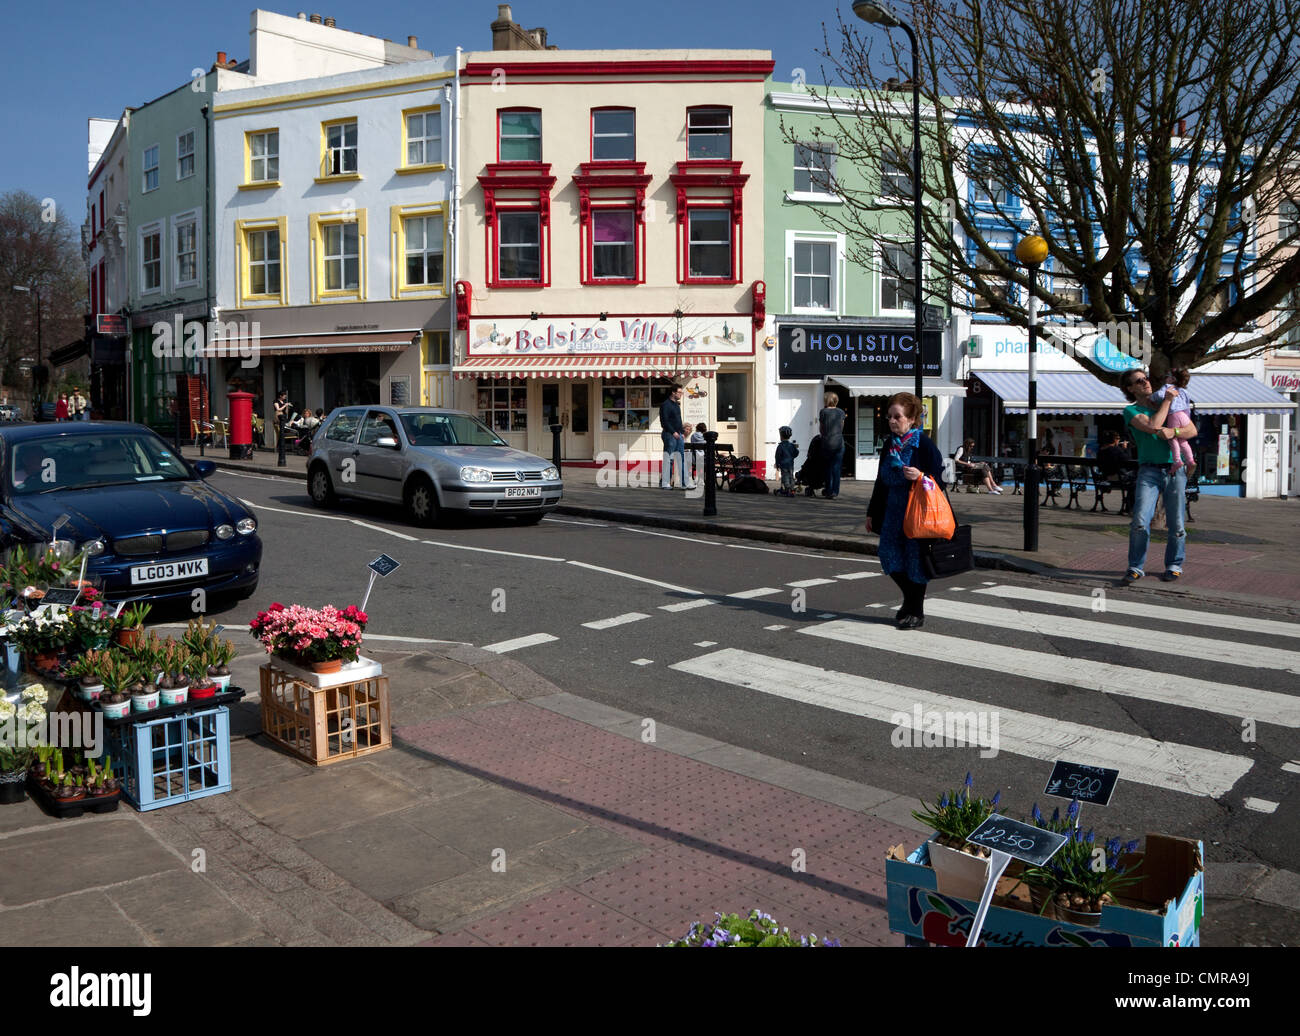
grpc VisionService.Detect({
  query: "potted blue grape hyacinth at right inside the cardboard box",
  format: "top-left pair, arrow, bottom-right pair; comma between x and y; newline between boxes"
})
1022,799 -> 1141,927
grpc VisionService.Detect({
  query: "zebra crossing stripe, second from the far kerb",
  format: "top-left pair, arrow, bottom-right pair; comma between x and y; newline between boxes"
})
926,598 -> 1300,675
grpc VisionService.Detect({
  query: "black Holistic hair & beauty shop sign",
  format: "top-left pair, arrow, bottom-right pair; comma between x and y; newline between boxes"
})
777,324 -> 944,378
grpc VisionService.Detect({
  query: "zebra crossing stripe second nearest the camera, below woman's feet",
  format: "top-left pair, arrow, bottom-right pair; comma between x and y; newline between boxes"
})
800,621 -> 1300,727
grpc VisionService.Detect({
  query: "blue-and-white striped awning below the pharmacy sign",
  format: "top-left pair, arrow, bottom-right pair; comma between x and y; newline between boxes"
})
975,370 -> 1296,413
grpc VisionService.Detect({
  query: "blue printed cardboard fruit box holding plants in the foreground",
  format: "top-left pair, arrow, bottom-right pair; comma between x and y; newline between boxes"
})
885,835 -> 1205,946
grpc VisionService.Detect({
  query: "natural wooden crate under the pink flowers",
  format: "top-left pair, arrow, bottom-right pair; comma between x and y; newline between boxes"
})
261,662 -> 393,766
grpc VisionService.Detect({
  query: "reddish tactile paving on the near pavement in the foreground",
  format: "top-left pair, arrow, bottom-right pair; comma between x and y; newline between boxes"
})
394,702 -> 919,946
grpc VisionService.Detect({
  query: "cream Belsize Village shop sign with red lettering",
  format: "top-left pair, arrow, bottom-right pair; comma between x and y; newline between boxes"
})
469,313 -> 754,356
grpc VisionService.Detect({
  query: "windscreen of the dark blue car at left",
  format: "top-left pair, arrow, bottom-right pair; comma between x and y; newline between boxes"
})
7,433 -> 194,495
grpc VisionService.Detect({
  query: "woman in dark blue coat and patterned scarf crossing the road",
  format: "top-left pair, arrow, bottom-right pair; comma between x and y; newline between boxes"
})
867,393 -> 944,629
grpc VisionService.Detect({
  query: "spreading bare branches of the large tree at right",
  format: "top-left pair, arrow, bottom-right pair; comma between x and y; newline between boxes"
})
785,0 -> 1300,381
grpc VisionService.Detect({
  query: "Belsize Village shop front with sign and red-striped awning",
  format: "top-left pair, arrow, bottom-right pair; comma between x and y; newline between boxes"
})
454,315 -> 755,469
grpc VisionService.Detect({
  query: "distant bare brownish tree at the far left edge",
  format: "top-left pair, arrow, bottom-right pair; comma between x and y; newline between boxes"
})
0,191 -> 87,402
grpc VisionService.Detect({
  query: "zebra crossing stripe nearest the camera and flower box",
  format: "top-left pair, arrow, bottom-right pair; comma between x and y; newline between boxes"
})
671,647 -> 1253,798
